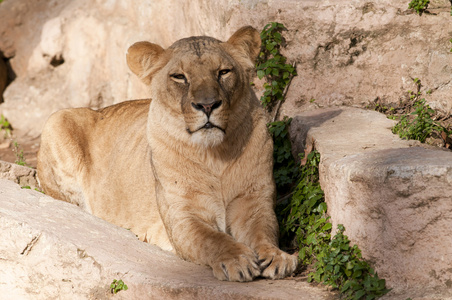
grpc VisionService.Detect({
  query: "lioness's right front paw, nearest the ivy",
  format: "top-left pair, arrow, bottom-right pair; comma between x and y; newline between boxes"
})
258,247 -> 298,279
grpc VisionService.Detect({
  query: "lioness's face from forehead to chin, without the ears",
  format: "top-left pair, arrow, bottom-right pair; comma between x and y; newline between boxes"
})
166,38 -> 243,147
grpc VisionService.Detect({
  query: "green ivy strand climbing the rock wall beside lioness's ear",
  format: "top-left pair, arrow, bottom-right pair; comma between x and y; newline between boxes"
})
256,22 -> 297,111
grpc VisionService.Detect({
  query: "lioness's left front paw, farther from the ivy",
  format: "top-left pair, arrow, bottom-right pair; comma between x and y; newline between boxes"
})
211,244 -> 261,282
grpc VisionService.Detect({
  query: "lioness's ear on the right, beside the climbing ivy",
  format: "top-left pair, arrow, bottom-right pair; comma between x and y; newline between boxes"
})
228,26 -> 261,62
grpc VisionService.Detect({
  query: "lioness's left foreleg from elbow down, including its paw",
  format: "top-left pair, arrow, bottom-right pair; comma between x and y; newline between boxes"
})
157,188 -> 261,281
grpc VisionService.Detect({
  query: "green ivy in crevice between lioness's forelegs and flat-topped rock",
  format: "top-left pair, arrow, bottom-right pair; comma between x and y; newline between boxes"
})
280,151 -> 389,300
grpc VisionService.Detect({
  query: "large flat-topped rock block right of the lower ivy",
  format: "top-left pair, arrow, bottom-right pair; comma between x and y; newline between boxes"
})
290,107 -> 452,299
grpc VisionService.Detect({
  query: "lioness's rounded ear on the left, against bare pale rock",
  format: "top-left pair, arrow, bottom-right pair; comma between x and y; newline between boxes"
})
126,42 -> 165,84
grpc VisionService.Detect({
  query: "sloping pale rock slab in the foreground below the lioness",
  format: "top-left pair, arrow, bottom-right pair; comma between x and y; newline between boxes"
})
0,179 -> 332,300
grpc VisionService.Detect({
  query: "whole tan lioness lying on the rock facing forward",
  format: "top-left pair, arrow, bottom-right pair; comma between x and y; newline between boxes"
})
38,27 -> 297,281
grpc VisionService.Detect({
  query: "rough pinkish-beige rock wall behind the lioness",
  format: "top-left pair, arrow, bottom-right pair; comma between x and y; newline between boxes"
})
0,0 -> 452,137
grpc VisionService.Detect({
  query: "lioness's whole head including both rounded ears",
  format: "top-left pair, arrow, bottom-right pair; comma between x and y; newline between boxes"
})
127,26 -> 261,147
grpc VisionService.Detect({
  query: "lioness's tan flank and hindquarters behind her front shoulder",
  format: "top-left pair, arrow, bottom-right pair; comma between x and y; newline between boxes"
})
38,100 -> 172,250
